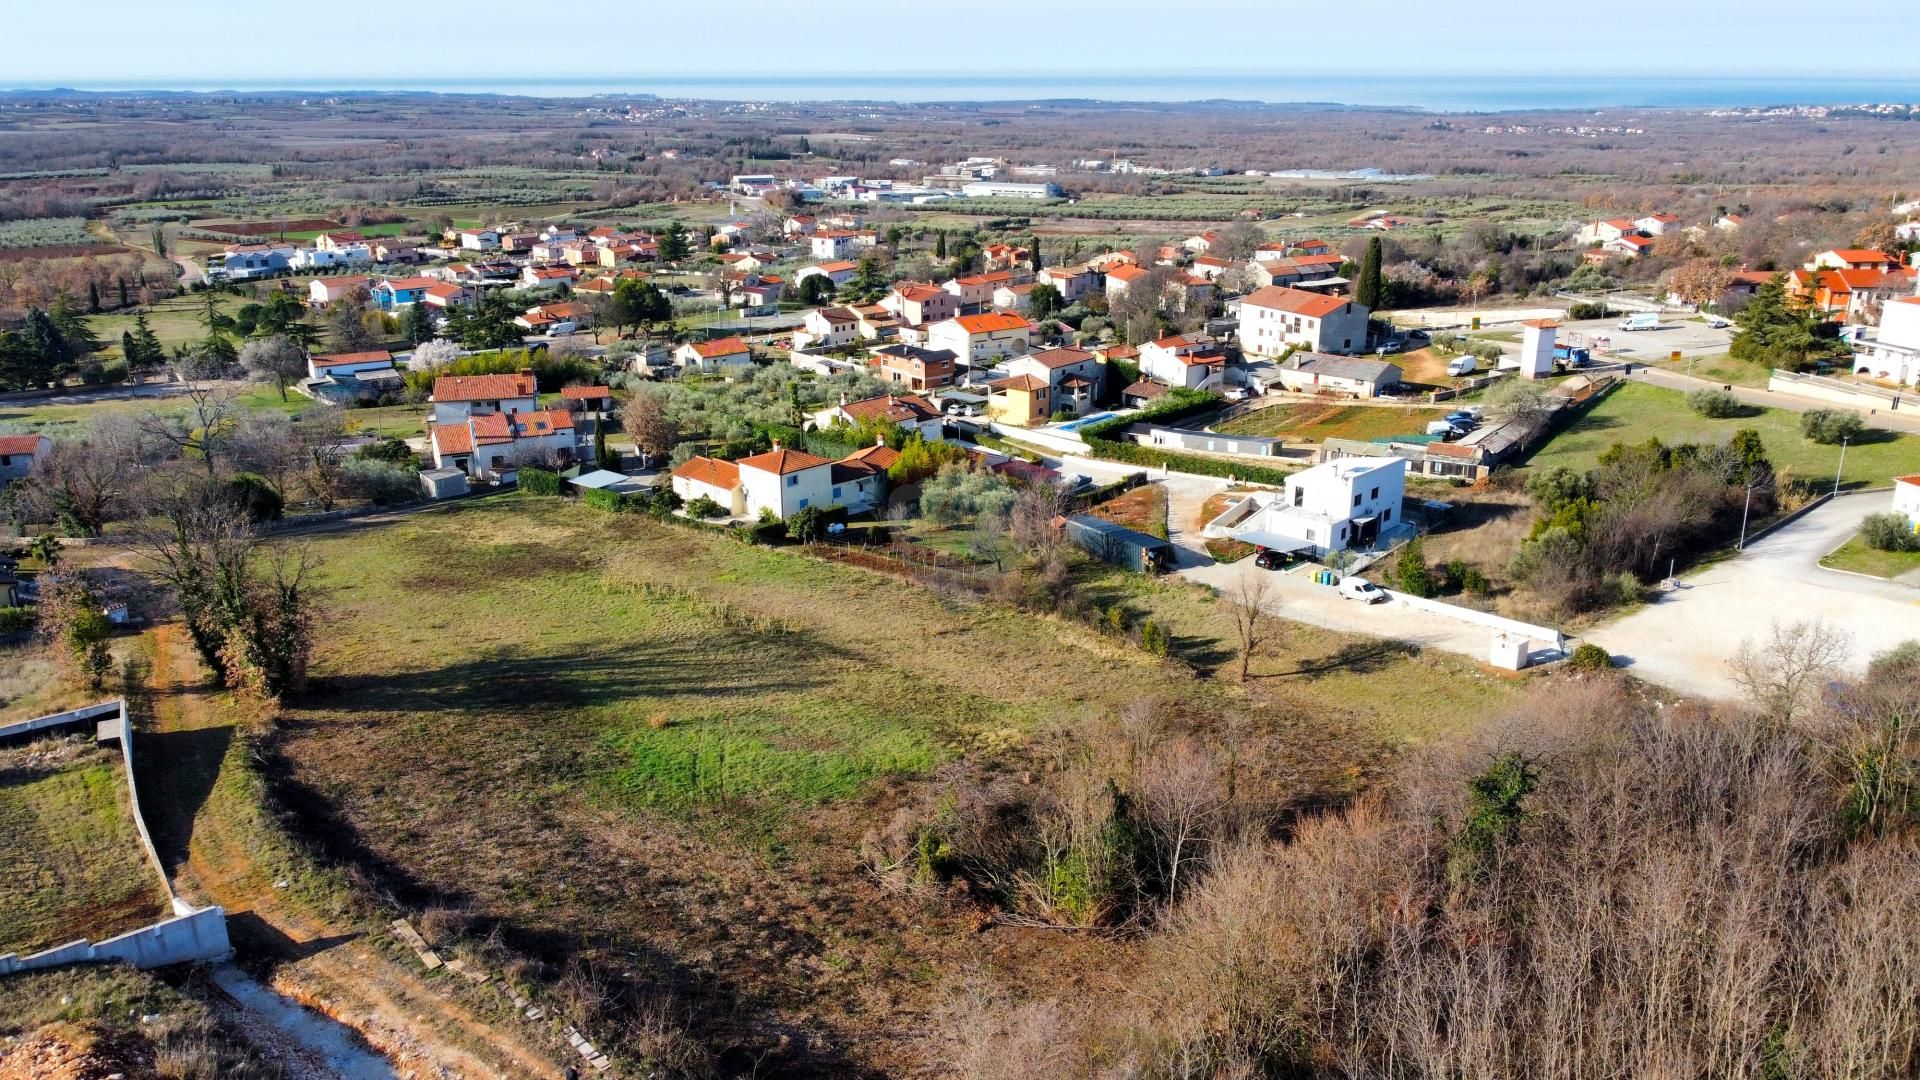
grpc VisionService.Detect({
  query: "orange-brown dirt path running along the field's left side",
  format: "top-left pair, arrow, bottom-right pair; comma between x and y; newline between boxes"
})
140,625 -> 561,1080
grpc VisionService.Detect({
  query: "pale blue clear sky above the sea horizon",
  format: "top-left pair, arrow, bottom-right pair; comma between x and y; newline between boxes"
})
0,0 -> 1920,88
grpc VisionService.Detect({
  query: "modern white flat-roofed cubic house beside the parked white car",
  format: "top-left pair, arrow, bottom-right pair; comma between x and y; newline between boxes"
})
1204,457 -> 1407,557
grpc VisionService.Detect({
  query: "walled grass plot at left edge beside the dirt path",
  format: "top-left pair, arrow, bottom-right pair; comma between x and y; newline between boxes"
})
0,740 -> 167,953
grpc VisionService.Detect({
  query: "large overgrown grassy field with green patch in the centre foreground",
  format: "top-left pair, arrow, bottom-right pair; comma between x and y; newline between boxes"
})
266,496 -> 1511,1074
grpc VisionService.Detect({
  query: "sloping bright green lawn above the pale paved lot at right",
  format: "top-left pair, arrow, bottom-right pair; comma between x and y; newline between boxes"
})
1526,382 -> 1920,488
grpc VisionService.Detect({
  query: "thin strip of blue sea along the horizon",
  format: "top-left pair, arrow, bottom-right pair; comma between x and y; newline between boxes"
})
26,69 -> 1920,113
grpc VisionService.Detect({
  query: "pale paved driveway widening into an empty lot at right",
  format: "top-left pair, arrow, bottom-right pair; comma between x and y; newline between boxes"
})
1588,492 -> 1920,698
